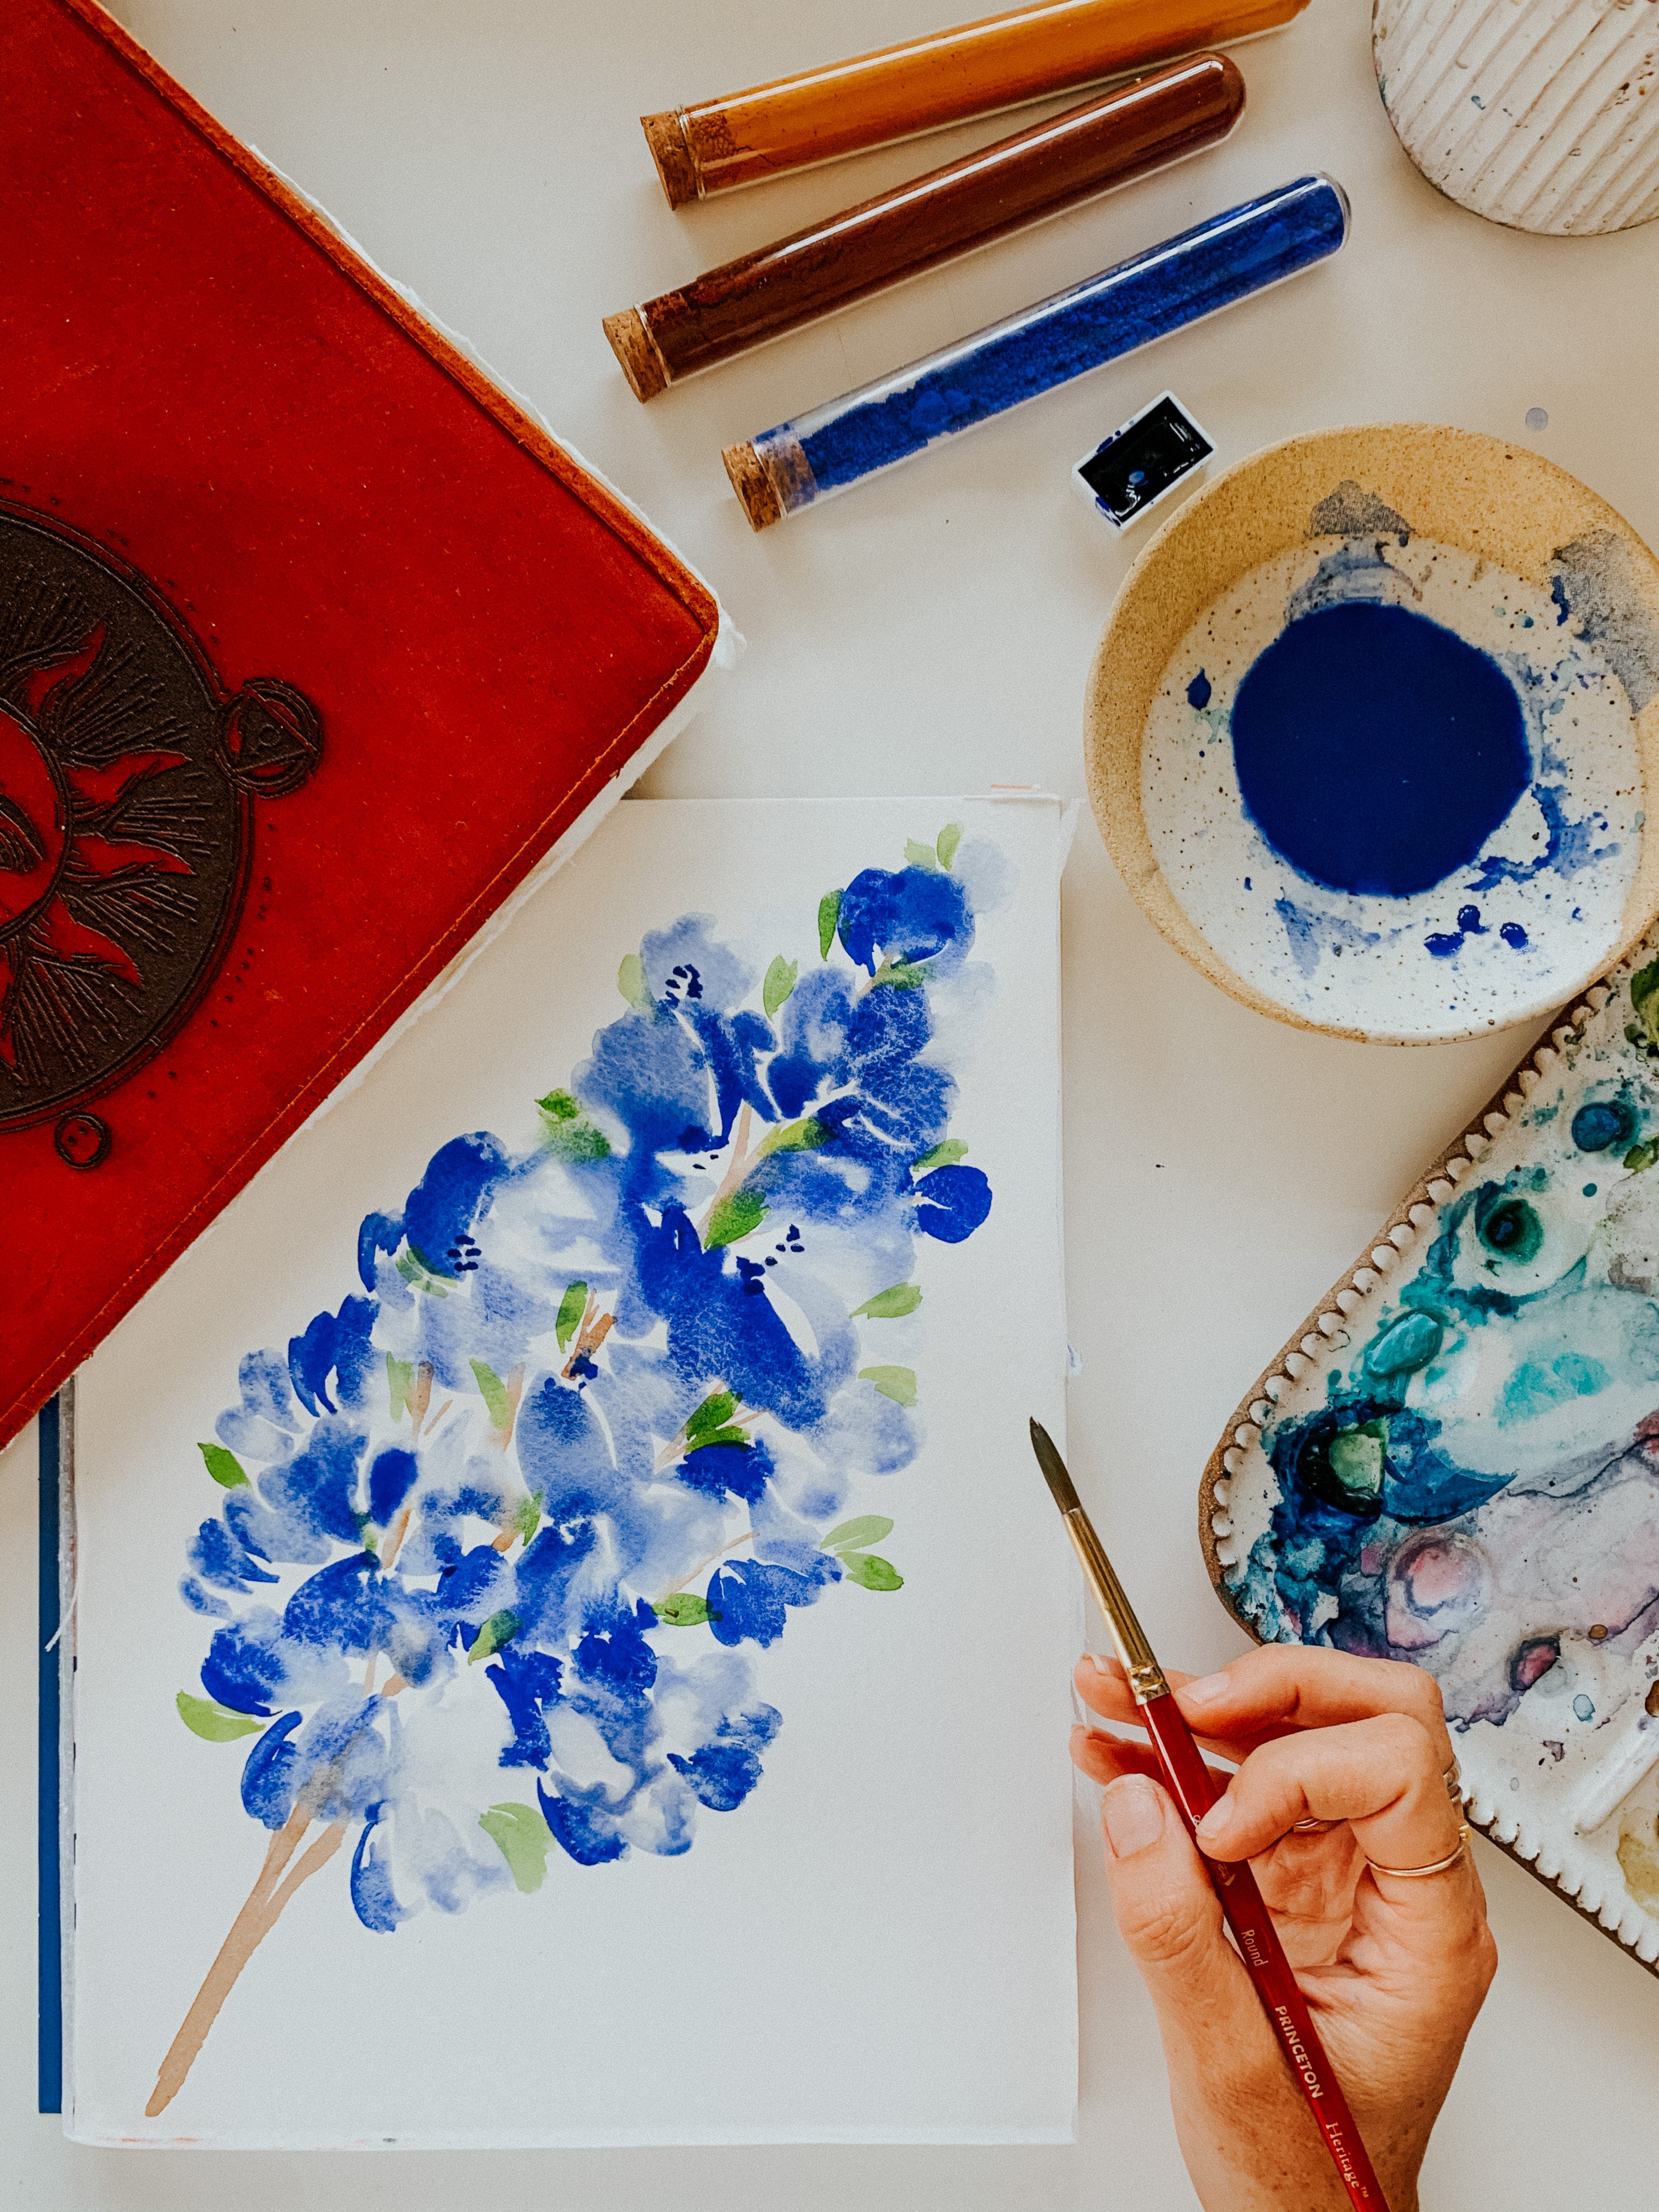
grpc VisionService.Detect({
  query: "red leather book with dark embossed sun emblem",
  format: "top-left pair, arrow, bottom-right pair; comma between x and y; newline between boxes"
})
0,0 -> 721,1442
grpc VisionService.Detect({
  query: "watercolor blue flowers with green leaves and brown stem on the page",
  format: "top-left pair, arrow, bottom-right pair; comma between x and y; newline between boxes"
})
146,823 -> 995,2117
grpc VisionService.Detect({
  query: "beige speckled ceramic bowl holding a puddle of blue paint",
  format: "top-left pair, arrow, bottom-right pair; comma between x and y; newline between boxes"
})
1084,422 -> 1659,1044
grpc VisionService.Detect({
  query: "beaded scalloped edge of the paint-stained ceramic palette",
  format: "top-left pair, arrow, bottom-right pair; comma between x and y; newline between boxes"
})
1199,929 -> 1659,1980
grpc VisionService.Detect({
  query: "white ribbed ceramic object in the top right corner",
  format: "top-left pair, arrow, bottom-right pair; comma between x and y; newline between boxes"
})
1372,0 -> 1659,236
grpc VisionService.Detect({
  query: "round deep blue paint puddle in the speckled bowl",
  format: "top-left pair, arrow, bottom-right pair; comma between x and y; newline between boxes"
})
1232,602 -> 1533,893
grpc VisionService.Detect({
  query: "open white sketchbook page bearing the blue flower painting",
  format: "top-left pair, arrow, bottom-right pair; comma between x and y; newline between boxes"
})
64,797 -> 1082,2148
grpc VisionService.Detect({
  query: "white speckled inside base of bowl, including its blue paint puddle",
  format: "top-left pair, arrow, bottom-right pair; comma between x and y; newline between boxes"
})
1142,531 -> 1644,1042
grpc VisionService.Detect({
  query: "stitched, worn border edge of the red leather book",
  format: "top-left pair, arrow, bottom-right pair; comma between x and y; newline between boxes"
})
0,0 -> 743,1449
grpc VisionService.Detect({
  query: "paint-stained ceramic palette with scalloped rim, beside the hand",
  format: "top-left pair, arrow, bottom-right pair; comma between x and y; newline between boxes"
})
1199,934 -> 1659,1971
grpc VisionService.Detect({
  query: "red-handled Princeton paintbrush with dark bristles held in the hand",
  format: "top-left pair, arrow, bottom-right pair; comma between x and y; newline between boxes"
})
1031,1420 -> 1387,2212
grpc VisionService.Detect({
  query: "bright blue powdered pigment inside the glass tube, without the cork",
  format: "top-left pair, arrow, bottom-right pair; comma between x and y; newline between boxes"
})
785,177 -> 1347,493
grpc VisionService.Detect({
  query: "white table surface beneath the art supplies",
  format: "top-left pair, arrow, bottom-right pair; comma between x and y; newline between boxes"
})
0,0 -> 1659,2212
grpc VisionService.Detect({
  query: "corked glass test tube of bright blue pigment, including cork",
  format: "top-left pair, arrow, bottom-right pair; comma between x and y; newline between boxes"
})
723,175 -> 1350,531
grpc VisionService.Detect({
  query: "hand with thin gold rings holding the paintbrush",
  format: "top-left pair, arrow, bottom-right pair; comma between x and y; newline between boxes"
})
1070,1644 -> 1498,2212
